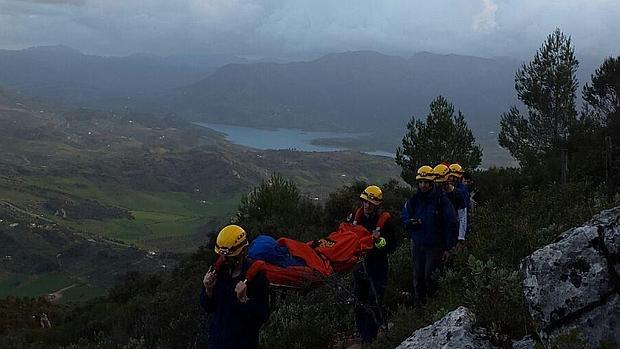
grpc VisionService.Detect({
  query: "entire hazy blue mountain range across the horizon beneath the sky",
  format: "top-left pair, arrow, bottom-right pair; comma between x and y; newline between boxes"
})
0,46 -> 602,165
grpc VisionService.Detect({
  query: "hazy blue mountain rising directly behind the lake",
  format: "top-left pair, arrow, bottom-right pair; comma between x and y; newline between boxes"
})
173,51 -> 520,130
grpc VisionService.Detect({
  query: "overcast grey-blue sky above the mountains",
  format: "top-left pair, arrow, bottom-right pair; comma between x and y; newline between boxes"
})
0,0 -> 620,59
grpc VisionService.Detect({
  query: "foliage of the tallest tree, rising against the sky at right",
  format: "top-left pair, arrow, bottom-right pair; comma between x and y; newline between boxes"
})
499,29 -> 579,167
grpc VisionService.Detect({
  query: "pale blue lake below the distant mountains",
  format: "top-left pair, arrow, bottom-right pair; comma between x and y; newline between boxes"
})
196,122 -> 394,157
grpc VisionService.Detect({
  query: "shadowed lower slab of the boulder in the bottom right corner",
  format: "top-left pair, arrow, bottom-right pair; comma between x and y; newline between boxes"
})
545,294 -> 620,349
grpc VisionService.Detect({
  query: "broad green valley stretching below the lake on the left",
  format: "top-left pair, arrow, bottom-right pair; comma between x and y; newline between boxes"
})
0,87 -> 399,302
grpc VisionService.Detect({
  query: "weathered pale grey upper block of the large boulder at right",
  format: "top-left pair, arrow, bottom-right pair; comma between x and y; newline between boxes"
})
521,226 -> 614,328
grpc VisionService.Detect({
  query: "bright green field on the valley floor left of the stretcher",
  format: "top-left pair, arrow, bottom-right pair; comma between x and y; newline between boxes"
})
7,177 -> 241,246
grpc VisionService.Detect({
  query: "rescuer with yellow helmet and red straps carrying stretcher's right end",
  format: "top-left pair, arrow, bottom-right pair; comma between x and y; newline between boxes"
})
349,185 -> 398,343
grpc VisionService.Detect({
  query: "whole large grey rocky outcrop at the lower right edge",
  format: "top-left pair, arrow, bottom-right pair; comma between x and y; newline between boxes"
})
521,207 -> 620,348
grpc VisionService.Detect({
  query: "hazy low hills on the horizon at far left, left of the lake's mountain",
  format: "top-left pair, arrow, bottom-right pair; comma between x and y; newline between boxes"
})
0,46 -> 245,106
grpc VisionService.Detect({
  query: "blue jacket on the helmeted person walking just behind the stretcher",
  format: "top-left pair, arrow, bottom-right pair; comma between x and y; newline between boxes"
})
400,187 -> 458,251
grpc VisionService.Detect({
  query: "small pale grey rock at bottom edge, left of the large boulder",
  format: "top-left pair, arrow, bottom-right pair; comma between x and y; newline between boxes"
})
397,307 -> 495,349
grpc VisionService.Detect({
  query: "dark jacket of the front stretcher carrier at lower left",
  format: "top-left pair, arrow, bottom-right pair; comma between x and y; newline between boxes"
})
200,262 -> 269,349
